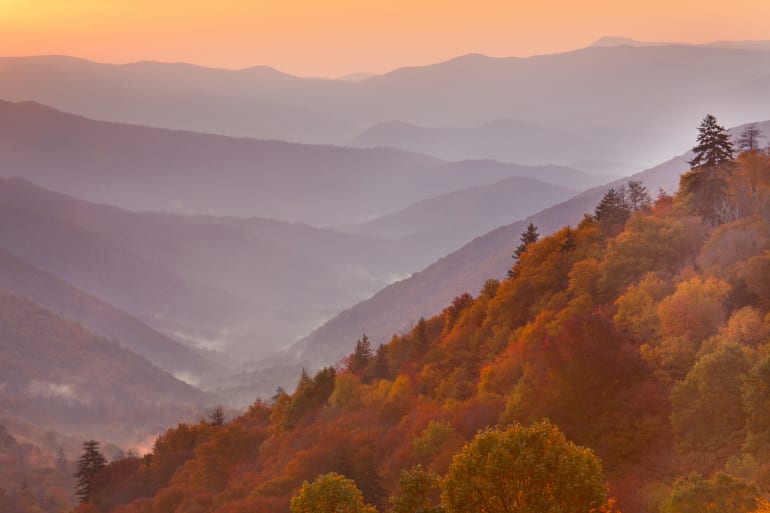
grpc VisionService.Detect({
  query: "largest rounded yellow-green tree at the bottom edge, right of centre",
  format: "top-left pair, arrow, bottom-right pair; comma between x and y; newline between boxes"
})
442,421 -> 607,513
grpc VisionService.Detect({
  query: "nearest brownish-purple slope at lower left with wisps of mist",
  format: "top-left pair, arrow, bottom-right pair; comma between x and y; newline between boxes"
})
0,291 -> 207,441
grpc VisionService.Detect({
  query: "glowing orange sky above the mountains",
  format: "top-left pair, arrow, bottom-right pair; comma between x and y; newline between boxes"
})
0,0 -> 770,76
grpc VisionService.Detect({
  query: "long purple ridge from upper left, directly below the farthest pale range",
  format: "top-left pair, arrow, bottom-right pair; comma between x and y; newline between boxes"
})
0,102 -> 595,226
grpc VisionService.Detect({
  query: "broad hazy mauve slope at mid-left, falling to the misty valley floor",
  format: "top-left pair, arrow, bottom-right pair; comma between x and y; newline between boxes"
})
0,179 -> 376,362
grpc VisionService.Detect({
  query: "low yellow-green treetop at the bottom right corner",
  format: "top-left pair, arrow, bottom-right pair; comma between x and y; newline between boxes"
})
660,472 -> 759,513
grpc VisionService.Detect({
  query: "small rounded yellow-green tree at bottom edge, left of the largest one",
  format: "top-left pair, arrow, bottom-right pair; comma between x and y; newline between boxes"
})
289,472 -> 377,513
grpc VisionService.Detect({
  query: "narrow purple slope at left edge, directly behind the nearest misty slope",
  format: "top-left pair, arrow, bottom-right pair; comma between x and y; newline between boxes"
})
0,250 -> 223,380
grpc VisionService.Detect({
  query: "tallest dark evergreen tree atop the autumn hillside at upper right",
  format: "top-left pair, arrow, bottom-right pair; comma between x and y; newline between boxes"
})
679,114 -> 735,225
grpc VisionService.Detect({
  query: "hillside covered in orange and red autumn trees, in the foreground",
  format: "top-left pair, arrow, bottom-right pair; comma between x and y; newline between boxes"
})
58,118 -> 770,513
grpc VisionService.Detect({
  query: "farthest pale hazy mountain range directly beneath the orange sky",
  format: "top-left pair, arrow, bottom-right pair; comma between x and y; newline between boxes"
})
6,41 -> 770,164
